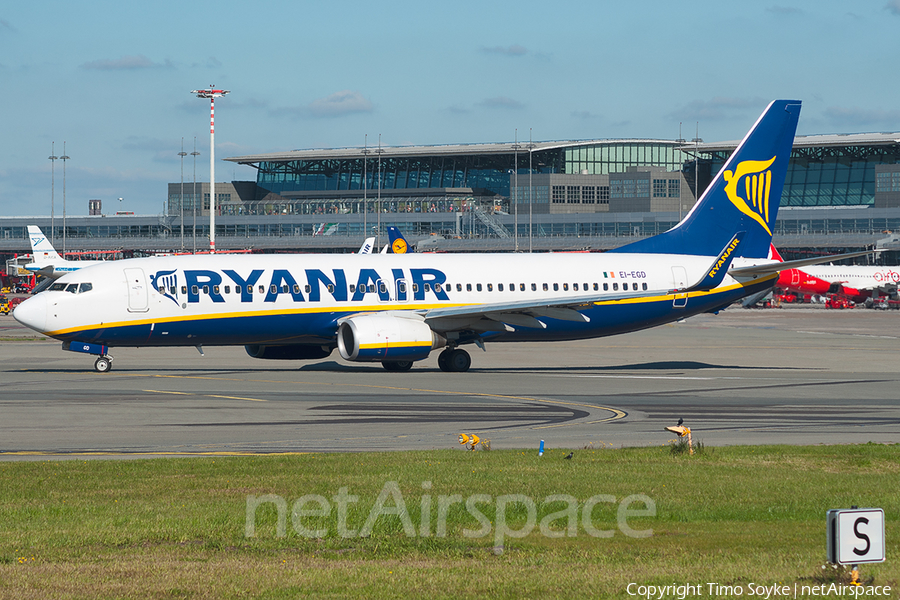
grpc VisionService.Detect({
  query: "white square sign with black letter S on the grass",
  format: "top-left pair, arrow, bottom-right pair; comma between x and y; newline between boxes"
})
827,508 -> 884,565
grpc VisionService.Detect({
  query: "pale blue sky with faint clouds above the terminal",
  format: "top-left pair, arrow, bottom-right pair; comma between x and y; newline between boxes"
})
0,0 -> 900,216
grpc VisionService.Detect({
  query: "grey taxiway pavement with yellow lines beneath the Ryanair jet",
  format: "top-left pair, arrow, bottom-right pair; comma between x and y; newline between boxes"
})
0,307 -> 900,460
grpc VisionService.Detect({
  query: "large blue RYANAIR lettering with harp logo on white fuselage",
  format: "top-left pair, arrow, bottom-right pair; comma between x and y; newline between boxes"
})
150,268 -> 449,304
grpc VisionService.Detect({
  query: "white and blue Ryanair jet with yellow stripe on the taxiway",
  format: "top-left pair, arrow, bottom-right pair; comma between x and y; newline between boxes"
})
14,100 -> 852,372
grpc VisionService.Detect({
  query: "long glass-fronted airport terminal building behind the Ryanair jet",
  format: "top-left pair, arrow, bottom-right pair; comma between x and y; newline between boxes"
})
0,133 -> 900,253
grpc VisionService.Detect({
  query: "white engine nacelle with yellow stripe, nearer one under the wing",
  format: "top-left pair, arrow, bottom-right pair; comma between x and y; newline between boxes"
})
338,314 -> 447,362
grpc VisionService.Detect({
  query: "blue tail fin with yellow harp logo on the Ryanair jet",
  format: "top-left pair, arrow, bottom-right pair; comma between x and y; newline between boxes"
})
611,100 -> 800,258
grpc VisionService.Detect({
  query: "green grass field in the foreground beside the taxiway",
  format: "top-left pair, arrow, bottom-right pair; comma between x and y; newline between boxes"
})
0,444 -> 900,598
